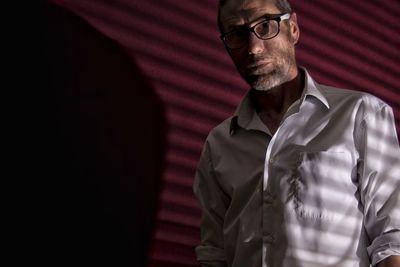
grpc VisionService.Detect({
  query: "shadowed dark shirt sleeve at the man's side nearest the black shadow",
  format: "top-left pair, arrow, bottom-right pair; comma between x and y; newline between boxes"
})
193,142 -> 227,267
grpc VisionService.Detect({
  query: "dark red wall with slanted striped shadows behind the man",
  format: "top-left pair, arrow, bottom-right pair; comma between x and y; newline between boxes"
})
49,0 -> 400,266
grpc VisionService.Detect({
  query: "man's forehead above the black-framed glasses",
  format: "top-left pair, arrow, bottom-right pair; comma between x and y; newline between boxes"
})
221,0 -> 280,26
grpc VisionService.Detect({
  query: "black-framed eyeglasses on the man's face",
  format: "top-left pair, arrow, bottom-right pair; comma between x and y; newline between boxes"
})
220,13 -> 290,49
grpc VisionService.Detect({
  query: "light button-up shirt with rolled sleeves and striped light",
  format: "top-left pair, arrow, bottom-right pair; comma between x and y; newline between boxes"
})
193,69 -> 400,267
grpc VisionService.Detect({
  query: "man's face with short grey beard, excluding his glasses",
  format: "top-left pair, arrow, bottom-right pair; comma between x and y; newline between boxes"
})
221,0 -> 299,91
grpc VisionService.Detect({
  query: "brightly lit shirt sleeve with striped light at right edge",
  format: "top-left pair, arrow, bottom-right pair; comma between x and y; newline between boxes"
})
358,105 -> 400,266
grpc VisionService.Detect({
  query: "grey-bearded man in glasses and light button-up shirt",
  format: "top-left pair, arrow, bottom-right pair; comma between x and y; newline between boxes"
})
193,0 -> 400,267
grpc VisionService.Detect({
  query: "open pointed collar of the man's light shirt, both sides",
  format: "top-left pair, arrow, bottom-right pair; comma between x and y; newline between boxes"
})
230,67 -> 329,135
